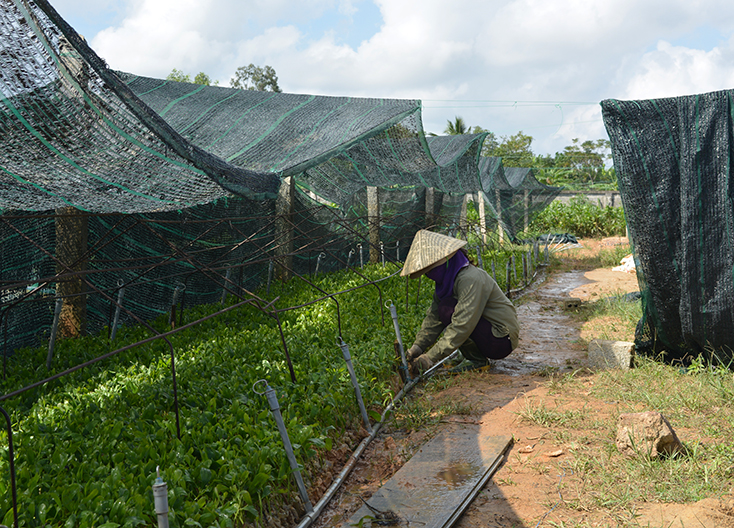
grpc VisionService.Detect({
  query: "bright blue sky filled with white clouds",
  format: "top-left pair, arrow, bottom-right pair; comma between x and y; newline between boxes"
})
50,0 -> 734,155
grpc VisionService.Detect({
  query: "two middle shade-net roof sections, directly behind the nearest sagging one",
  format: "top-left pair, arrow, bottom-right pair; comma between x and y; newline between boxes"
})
125,73 -> 494,206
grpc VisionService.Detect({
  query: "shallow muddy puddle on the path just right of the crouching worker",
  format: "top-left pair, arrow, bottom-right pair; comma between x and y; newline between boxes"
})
492,270 -> 592,375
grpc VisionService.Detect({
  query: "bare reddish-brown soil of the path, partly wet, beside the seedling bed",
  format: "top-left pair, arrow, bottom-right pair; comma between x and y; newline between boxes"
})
312,239 -> 734,528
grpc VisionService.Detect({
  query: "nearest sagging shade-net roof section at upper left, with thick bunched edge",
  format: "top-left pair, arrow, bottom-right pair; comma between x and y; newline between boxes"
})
0,0 -> 279,213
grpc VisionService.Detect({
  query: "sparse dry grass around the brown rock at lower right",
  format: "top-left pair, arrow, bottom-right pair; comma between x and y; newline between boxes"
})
532,358 -> 734,520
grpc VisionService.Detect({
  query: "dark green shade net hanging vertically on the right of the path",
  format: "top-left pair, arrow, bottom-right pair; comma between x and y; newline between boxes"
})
602,90 -> 734,363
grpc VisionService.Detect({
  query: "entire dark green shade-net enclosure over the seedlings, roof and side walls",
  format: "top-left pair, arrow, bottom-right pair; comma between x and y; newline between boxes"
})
0,0 -> 564,351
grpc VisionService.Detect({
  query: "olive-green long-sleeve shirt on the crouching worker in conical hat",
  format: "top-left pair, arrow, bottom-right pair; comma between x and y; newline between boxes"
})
414,264 -> 520,362
